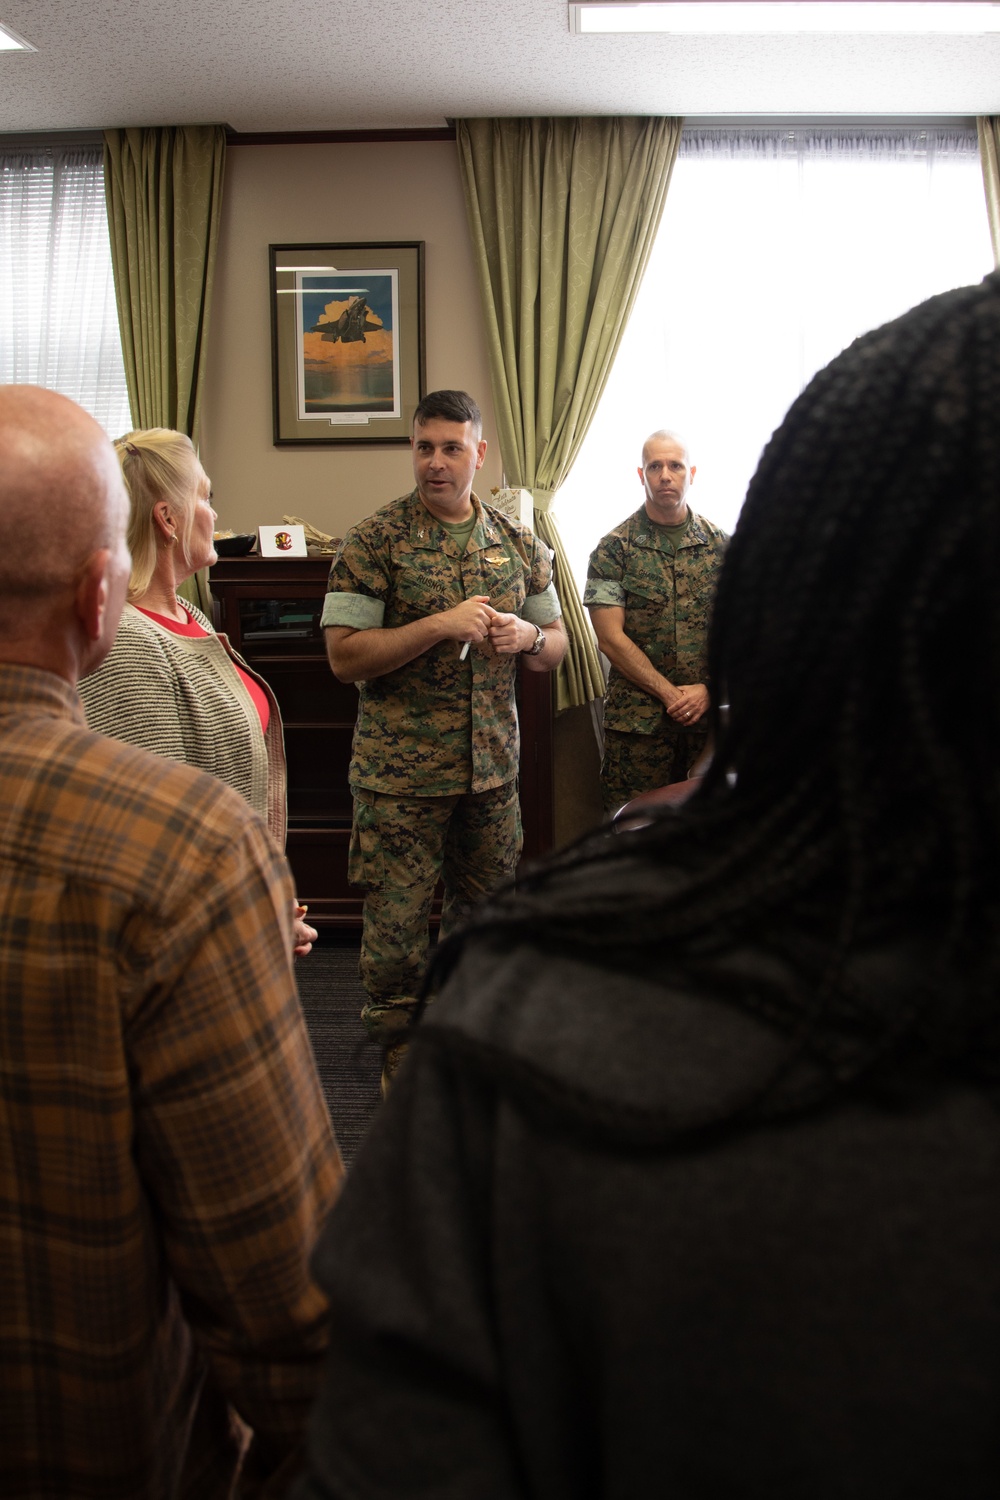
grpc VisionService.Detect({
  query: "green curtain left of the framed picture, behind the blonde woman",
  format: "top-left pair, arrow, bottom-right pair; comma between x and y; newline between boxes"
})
103,125 -> 226,614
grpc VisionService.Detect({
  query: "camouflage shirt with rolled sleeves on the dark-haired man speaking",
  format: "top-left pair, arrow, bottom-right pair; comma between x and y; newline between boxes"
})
322,491 -> 561,797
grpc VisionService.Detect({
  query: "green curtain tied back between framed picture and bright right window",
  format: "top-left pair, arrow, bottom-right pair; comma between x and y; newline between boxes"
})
457,117 -> 681,710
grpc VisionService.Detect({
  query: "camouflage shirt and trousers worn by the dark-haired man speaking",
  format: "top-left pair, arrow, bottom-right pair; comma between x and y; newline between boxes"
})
322,489 -> 561,1049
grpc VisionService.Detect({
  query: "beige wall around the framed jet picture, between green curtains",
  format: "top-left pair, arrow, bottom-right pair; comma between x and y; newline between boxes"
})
201,141 -> 501,536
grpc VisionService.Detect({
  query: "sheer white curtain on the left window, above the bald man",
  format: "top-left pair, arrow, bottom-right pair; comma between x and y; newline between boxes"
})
0,146 -> 132,437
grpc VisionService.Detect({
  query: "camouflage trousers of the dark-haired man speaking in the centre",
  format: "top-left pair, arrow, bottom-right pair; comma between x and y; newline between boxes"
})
348,780 -> 522,1047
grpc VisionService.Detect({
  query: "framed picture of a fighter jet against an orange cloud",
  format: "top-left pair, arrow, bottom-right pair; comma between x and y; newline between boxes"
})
268,240 -> 424,447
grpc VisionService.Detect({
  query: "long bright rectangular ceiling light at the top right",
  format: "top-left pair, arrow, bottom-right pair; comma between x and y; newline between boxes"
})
570,0 -> 1000,36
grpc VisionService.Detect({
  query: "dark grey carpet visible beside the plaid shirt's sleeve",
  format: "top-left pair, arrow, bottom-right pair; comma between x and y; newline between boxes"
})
295,936 -> 382,1166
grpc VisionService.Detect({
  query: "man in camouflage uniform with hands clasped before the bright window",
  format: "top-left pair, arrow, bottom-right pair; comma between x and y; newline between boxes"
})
583,434 -> 729,813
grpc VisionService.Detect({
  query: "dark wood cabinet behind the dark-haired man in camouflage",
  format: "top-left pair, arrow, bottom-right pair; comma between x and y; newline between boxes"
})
211,557 -> 553,927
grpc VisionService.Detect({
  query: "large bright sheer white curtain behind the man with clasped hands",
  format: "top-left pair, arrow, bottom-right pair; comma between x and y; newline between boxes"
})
556,128 -> 993,578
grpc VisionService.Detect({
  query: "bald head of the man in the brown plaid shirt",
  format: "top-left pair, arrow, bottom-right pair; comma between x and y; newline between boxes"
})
0,386 -> 127,675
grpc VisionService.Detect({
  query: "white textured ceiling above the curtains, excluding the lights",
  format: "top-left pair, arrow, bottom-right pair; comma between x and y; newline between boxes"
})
0,0 -> 1000,132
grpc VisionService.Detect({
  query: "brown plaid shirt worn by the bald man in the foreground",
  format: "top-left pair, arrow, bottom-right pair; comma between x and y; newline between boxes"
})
0,665 -> 342,1500
